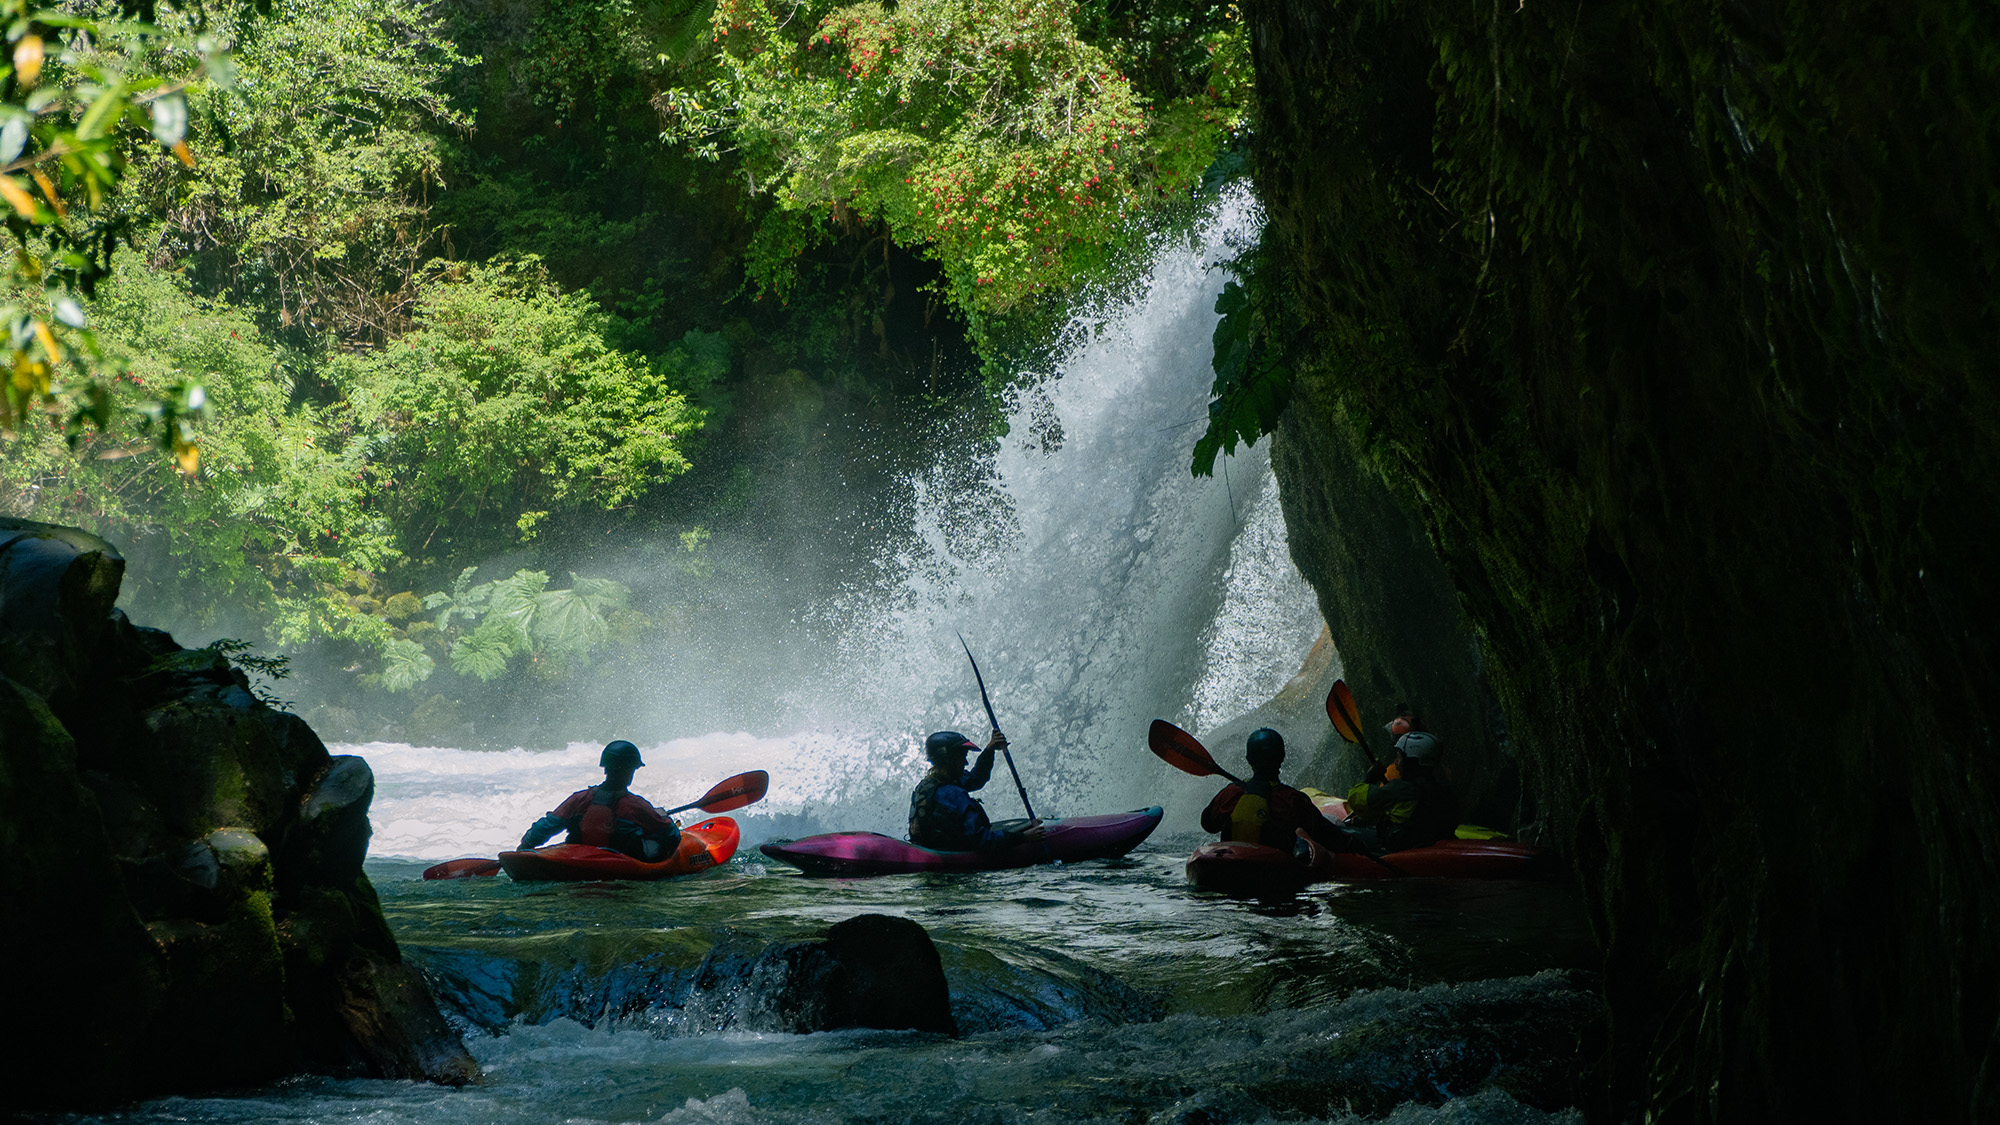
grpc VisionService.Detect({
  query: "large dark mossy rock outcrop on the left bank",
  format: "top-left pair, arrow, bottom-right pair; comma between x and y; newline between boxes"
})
0,518 -> 478,1107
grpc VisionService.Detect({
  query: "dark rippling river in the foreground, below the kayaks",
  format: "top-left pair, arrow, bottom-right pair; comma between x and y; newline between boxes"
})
43,839 -> 1596,1125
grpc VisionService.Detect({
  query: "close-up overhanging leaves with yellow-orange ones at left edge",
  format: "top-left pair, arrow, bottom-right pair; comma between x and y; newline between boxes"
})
0,0 -> 228,464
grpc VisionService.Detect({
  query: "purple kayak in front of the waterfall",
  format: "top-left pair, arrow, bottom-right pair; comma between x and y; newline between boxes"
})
758,805 -> 1160,875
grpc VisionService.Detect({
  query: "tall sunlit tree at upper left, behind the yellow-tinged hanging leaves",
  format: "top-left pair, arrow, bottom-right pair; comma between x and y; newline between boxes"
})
128,0 -> 472,342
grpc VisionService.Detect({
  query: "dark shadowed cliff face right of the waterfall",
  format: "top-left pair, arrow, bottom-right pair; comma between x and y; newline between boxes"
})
1246,0 -> 2000,1121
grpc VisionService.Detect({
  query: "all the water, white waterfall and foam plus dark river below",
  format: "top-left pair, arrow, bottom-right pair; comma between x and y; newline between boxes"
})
47,194 -> 1602,1125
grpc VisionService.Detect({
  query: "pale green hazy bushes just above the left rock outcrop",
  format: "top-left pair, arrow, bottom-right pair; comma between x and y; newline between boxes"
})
0,258 -> 400,645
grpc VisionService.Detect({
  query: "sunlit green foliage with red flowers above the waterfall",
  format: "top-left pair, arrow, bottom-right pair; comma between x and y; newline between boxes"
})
664,0 -> 1244,314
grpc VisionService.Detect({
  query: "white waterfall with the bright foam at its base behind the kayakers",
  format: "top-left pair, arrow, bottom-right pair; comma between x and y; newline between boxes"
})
352,190 -> 1320,857
